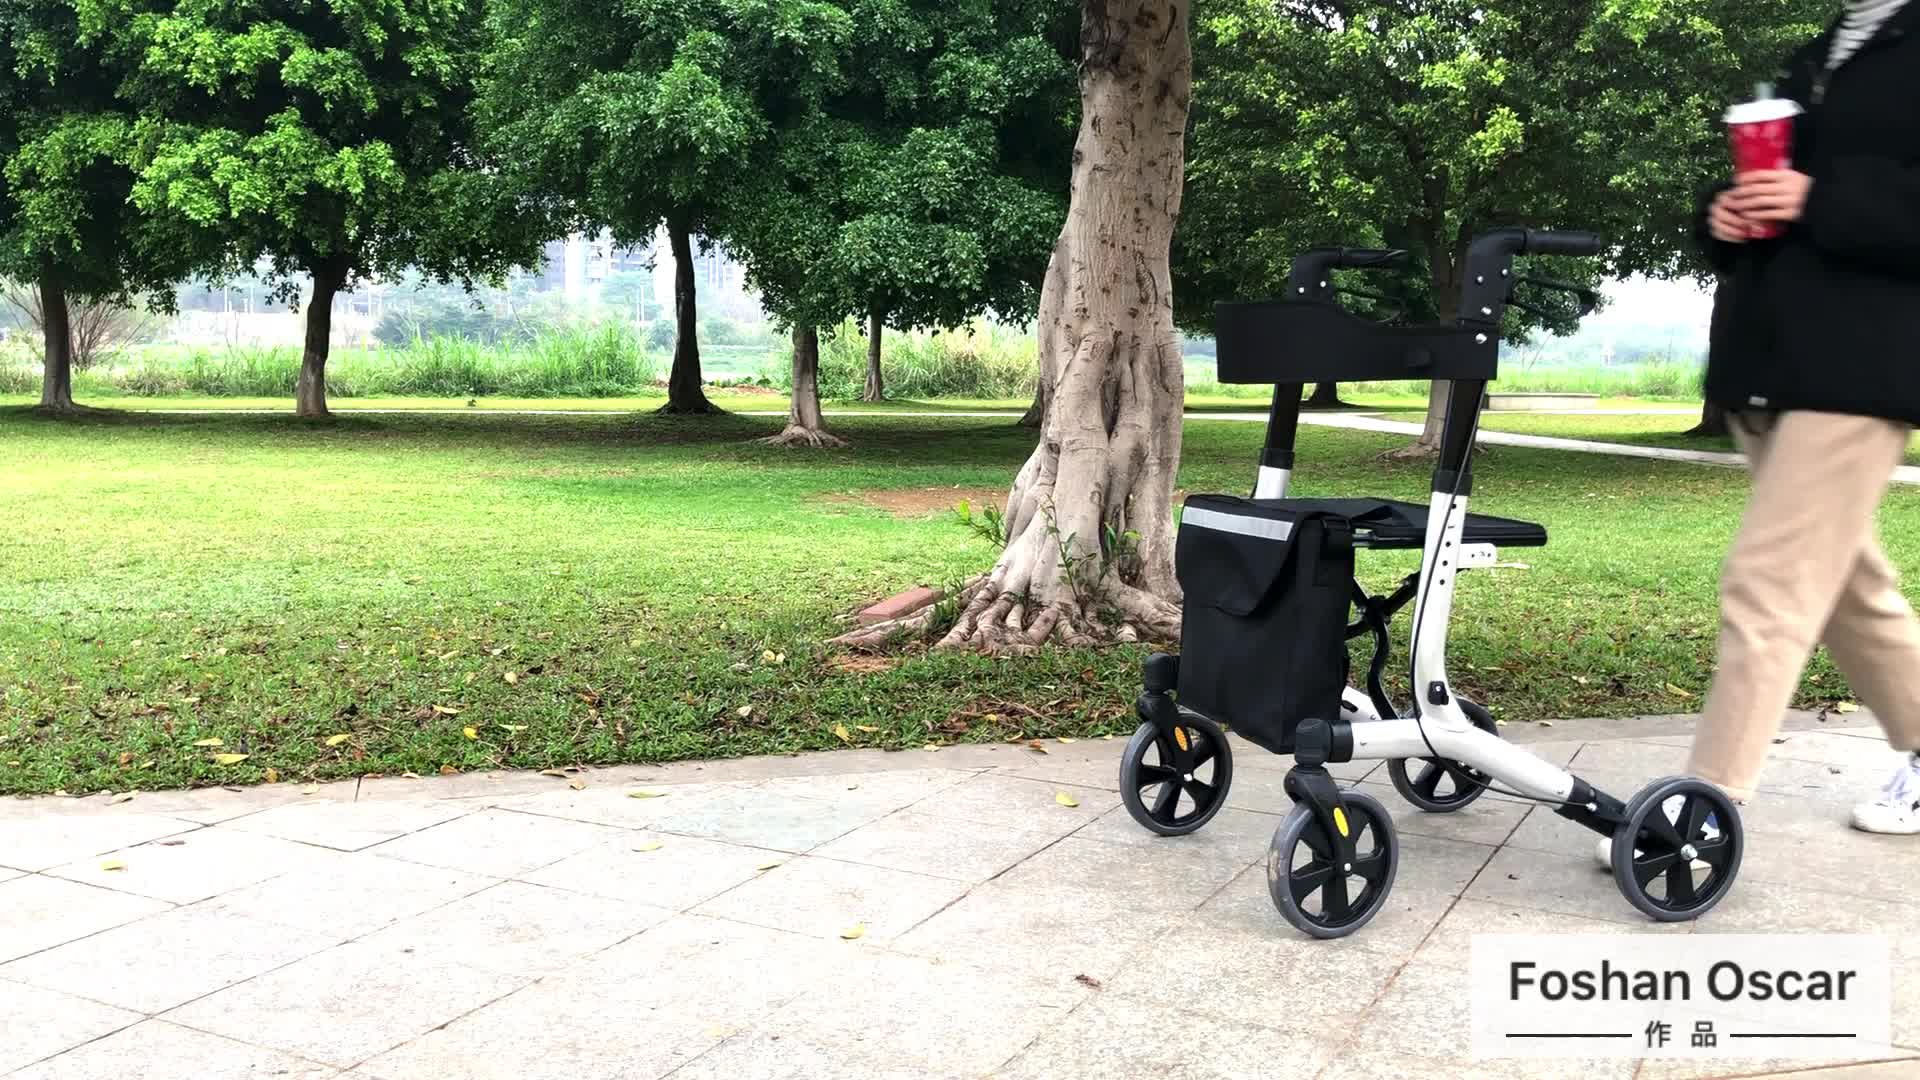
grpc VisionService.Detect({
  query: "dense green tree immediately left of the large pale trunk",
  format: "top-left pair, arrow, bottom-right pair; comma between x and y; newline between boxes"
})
732,0 -> 1073,429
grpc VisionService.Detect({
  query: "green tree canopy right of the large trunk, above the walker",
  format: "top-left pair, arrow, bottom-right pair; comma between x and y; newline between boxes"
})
1175,0 -> 1832,438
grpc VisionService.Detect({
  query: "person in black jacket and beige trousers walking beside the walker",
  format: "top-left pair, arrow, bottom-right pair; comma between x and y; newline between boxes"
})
1688,0 -> 1920,834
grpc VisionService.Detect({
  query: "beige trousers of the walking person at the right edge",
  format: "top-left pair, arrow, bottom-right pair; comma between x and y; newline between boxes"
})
1688,413 -> 1920,799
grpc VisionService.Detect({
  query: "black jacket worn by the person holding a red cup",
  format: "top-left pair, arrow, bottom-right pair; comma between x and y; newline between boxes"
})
1697,0 -> 1920,425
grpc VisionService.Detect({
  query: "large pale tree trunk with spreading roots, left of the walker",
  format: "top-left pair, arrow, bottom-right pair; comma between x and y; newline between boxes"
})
841,0 -> 1192,651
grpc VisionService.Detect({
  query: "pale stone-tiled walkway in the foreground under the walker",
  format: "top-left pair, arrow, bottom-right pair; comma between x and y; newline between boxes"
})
0,717 -> 1920,1080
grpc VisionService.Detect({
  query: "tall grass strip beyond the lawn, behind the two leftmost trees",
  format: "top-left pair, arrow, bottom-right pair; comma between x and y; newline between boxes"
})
11,323 -> 660,398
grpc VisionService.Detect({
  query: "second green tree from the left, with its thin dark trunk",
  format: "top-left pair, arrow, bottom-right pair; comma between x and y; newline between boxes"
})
102,0 -> 551,415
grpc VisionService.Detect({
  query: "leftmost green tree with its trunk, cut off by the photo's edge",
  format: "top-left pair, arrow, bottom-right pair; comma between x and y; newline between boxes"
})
0,0 -> 196,411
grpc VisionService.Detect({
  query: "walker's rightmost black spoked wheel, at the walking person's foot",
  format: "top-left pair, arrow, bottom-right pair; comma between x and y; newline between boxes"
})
1613,776 -> 1747,922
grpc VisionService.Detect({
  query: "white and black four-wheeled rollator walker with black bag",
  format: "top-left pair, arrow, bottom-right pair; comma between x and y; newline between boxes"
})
1119,229 -> 1745,938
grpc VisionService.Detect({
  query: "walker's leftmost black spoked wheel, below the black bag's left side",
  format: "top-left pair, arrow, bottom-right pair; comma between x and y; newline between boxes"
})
1119,713 -> 1233,836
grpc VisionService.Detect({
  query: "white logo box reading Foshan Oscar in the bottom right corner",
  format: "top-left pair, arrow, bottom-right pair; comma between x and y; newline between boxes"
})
1471,934 -> 1895,1061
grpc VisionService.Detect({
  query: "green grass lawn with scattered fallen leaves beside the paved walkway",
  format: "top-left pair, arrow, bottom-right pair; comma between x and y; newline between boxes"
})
0,401 -> 1920,792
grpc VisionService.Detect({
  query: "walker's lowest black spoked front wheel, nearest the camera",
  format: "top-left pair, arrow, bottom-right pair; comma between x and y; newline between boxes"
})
1267,792 -> 1400,938
